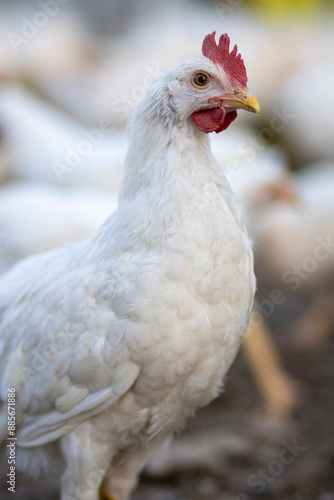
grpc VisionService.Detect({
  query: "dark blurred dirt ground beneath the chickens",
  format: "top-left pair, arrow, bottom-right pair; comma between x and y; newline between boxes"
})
0,308 -> 334,500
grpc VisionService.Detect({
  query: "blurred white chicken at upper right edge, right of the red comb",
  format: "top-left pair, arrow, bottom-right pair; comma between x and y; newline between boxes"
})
275,24 -> 334,165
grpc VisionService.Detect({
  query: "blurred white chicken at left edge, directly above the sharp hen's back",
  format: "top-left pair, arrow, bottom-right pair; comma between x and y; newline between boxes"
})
0,182 -> 117,272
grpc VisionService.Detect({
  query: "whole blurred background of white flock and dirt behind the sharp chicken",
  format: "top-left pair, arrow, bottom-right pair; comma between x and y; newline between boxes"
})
0,0 -> 334,500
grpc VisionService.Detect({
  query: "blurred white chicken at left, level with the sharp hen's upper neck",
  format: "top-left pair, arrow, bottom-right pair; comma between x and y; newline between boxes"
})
0,84 -> 126,192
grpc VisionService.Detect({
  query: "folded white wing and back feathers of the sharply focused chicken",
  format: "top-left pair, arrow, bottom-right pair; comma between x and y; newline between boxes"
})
0,244 -> 139,447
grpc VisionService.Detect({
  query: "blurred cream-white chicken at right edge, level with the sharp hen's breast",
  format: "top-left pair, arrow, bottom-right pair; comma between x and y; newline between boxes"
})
253,163 -> 334,350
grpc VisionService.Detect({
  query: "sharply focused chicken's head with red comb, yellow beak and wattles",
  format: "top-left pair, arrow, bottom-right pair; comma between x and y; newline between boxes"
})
169,32 -> 260,133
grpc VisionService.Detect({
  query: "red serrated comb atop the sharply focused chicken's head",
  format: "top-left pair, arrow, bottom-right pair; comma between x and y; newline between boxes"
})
202,31 -> 247,87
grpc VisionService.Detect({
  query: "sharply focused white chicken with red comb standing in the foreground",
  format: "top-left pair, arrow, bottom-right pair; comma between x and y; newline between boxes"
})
0,33 -> 259,500
